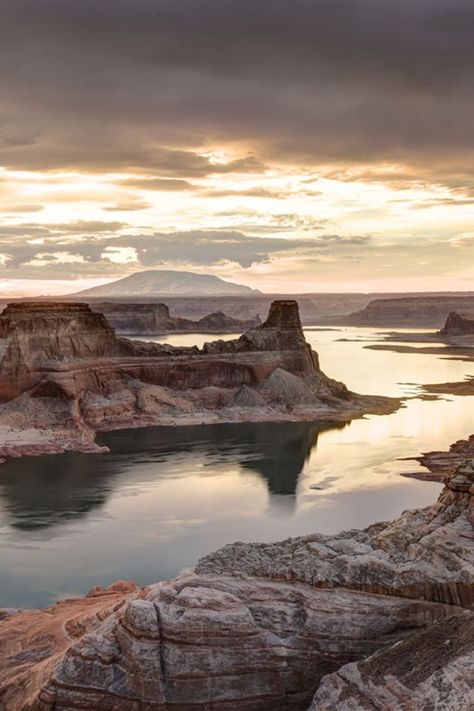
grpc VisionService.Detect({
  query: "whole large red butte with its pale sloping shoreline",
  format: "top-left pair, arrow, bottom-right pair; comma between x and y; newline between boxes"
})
0,301 -> 399,458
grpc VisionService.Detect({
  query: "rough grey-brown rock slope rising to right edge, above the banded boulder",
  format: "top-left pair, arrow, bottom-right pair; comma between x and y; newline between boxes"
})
196,461 -> 474,608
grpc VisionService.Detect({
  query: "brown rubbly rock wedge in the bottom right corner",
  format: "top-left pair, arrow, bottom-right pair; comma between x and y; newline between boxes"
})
309,612 -> 474,711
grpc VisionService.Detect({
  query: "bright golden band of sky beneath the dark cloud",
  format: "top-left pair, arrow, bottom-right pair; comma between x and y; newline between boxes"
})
0,152 -> 474,293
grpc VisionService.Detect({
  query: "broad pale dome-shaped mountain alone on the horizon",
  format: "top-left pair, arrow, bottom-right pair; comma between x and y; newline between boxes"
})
71,269 -> 260,298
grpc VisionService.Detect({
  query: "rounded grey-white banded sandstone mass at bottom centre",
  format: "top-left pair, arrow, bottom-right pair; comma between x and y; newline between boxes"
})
0,573 -> 462,711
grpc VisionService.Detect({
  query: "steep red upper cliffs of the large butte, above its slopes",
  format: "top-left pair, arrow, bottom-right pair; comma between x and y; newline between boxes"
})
0,301 -> 318,401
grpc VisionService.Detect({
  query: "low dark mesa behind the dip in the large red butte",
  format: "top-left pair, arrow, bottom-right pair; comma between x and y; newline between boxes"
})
91,302 -> 260,336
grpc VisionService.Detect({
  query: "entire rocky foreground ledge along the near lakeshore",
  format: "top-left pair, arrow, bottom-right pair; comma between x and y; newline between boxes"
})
0,454 -> 474,711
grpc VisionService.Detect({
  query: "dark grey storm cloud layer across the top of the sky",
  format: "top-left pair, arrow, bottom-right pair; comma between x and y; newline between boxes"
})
0,0 -> 474,188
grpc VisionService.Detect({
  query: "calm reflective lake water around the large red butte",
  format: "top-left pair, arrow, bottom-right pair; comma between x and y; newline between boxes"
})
0,328 -> 474,607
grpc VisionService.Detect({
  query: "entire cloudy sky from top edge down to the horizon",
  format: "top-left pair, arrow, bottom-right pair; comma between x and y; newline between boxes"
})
0,0 -> 474,296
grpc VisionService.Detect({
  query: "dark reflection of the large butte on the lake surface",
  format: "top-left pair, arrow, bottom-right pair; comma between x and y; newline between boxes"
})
0,422 -> 345,531
